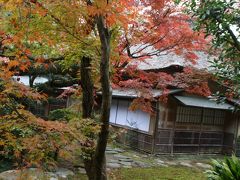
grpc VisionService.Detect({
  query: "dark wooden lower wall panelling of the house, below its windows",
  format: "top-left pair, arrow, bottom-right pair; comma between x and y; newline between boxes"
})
118,126 -> 234,154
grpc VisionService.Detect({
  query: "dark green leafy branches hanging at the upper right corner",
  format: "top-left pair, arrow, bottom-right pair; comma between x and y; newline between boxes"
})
184,0 -> 240,102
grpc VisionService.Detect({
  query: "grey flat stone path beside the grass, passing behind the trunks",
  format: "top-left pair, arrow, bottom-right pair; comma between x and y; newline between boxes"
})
0,147 -> 214,180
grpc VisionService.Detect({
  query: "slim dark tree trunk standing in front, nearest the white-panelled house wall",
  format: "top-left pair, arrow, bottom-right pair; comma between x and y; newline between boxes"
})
94,16 -> 112,180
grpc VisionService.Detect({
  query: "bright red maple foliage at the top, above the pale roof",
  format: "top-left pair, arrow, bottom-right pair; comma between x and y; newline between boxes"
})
114,0 -> 208,68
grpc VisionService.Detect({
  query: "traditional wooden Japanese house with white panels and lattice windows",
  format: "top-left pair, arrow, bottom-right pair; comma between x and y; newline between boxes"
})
110,51 -> 240,154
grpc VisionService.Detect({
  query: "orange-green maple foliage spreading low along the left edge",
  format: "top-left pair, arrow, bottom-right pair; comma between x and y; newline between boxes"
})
0,62 -> 92,168
